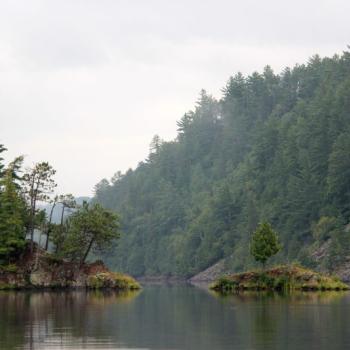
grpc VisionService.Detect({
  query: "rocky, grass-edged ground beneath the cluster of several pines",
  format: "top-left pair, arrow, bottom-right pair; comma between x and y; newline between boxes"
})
0,246 -> 140,290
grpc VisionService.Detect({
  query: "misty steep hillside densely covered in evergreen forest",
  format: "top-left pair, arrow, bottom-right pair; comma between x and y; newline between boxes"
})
96,52 -> 350,276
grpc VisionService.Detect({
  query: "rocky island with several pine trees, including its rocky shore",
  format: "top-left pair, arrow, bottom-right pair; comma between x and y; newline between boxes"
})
0,157 -> 140,290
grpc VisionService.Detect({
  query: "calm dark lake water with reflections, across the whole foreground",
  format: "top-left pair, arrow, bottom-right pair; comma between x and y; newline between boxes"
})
0,285 -> 350,350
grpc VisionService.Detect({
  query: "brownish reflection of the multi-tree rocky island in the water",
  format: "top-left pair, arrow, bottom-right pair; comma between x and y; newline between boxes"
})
0,291 -> 138,350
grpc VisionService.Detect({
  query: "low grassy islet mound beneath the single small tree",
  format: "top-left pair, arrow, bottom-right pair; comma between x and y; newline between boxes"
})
210,265 -> 350,293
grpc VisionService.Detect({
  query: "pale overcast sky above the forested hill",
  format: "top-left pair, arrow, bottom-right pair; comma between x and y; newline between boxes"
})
0,0 -> 350,195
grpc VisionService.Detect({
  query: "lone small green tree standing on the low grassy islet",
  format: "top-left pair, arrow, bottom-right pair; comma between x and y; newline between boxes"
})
250,222 -> 282,268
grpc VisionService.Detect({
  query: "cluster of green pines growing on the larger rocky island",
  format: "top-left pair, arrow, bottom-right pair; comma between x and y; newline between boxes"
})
0,152 -> 119,267
